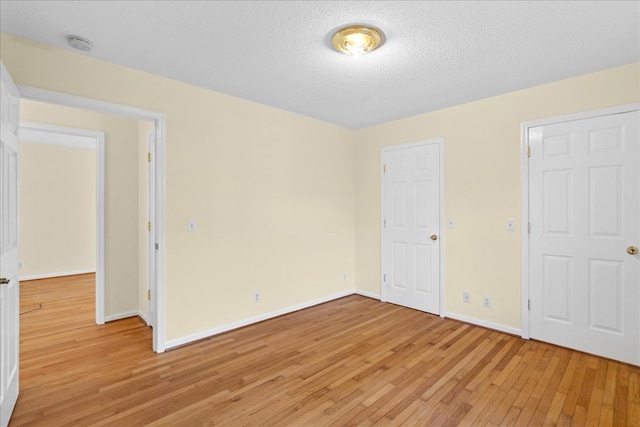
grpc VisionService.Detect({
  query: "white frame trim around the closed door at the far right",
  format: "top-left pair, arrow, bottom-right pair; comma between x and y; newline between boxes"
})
520,104 -> 640,339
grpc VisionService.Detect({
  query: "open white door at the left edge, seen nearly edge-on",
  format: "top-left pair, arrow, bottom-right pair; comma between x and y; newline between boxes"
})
0,62 -> 20,427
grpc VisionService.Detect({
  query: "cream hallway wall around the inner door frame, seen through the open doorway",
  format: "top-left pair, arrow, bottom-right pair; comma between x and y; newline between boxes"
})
19,98 -> 139,317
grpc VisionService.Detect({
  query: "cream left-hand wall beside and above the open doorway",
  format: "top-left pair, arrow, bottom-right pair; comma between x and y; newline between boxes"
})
0,34 -> 355,340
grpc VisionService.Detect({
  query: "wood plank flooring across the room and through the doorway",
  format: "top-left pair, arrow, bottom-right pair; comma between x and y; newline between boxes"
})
10,275 -> 640,427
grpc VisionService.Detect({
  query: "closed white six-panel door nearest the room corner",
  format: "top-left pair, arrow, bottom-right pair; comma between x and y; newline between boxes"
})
382,140 -> 441,314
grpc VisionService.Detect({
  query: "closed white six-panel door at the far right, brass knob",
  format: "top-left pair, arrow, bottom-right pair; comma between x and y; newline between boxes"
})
529,111 -> 640,365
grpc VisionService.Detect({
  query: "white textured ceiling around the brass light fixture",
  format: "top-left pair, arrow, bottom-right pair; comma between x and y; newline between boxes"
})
0,0 -> 640,128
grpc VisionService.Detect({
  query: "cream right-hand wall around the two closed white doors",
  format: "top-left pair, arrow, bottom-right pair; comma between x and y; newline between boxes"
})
355,63 -> 640,329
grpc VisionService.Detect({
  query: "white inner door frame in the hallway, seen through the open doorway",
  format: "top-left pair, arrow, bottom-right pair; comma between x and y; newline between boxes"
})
20,121 -> 105,325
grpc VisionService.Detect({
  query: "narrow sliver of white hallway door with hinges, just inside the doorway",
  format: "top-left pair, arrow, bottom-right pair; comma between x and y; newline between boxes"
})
147,131 -> 156,328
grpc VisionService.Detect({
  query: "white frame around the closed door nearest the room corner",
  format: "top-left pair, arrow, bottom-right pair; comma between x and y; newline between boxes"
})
380,138 -> 445,318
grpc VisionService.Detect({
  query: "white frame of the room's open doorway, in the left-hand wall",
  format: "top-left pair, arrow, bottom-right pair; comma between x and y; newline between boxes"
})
18,86 -> 166,353
